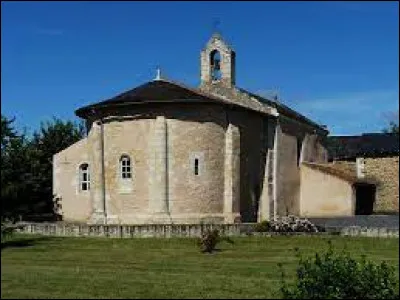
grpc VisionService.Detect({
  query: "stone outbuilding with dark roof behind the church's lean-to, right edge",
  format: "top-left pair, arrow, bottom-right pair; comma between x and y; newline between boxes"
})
327,133 -> 399,214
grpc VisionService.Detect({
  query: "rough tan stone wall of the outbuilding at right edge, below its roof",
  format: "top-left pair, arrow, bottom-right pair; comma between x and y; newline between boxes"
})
364,156 -> 399,212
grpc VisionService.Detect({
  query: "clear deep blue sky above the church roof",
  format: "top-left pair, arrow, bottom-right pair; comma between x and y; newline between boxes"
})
1,1 -> 399,135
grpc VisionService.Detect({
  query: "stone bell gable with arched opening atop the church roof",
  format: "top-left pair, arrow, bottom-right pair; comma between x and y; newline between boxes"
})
200,33 -> 236,87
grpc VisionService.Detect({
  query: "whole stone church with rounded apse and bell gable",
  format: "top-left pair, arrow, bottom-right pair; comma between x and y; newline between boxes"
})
53,34 -> 344,224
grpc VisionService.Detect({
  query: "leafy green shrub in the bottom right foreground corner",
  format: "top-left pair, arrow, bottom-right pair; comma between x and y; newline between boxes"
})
280,244 -> 399,299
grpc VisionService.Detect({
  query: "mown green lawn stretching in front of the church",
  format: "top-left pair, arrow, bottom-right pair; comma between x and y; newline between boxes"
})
1,236 -> 399,299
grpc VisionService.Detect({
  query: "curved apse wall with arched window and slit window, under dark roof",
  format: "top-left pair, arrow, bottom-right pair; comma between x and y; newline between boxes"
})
92,105 -> 231,224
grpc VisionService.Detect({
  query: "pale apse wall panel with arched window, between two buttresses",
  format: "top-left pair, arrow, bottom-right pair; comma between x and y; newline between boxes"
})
102,118 -> 155,222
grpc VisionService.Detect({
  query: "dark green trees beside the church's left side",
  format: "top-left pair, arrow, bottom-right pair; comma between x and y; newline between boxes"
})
1,115 -> 85,220
